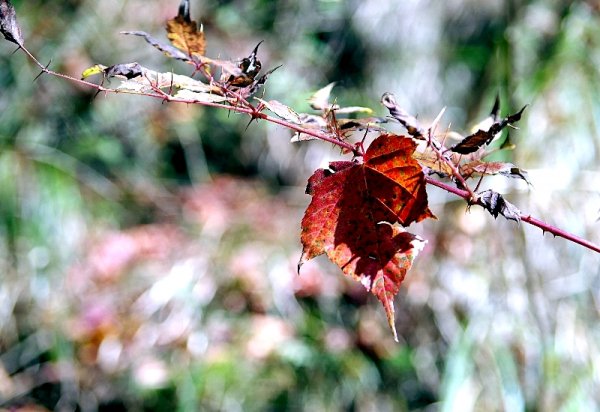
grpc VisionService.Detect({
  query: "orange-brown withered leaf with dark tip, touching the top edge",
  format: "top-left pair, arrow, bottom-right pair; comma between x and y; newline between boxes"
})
167,0 -> 206,56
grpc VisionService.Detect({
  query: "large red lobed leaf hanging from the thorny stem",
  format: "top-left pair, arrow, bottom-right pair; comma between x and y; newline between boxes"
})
299,134 -> 434,337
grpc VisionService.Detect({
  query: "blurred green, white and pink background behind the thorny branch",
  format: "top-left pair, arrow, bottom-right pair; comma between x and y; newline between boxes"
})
0,0 -> 600,411
